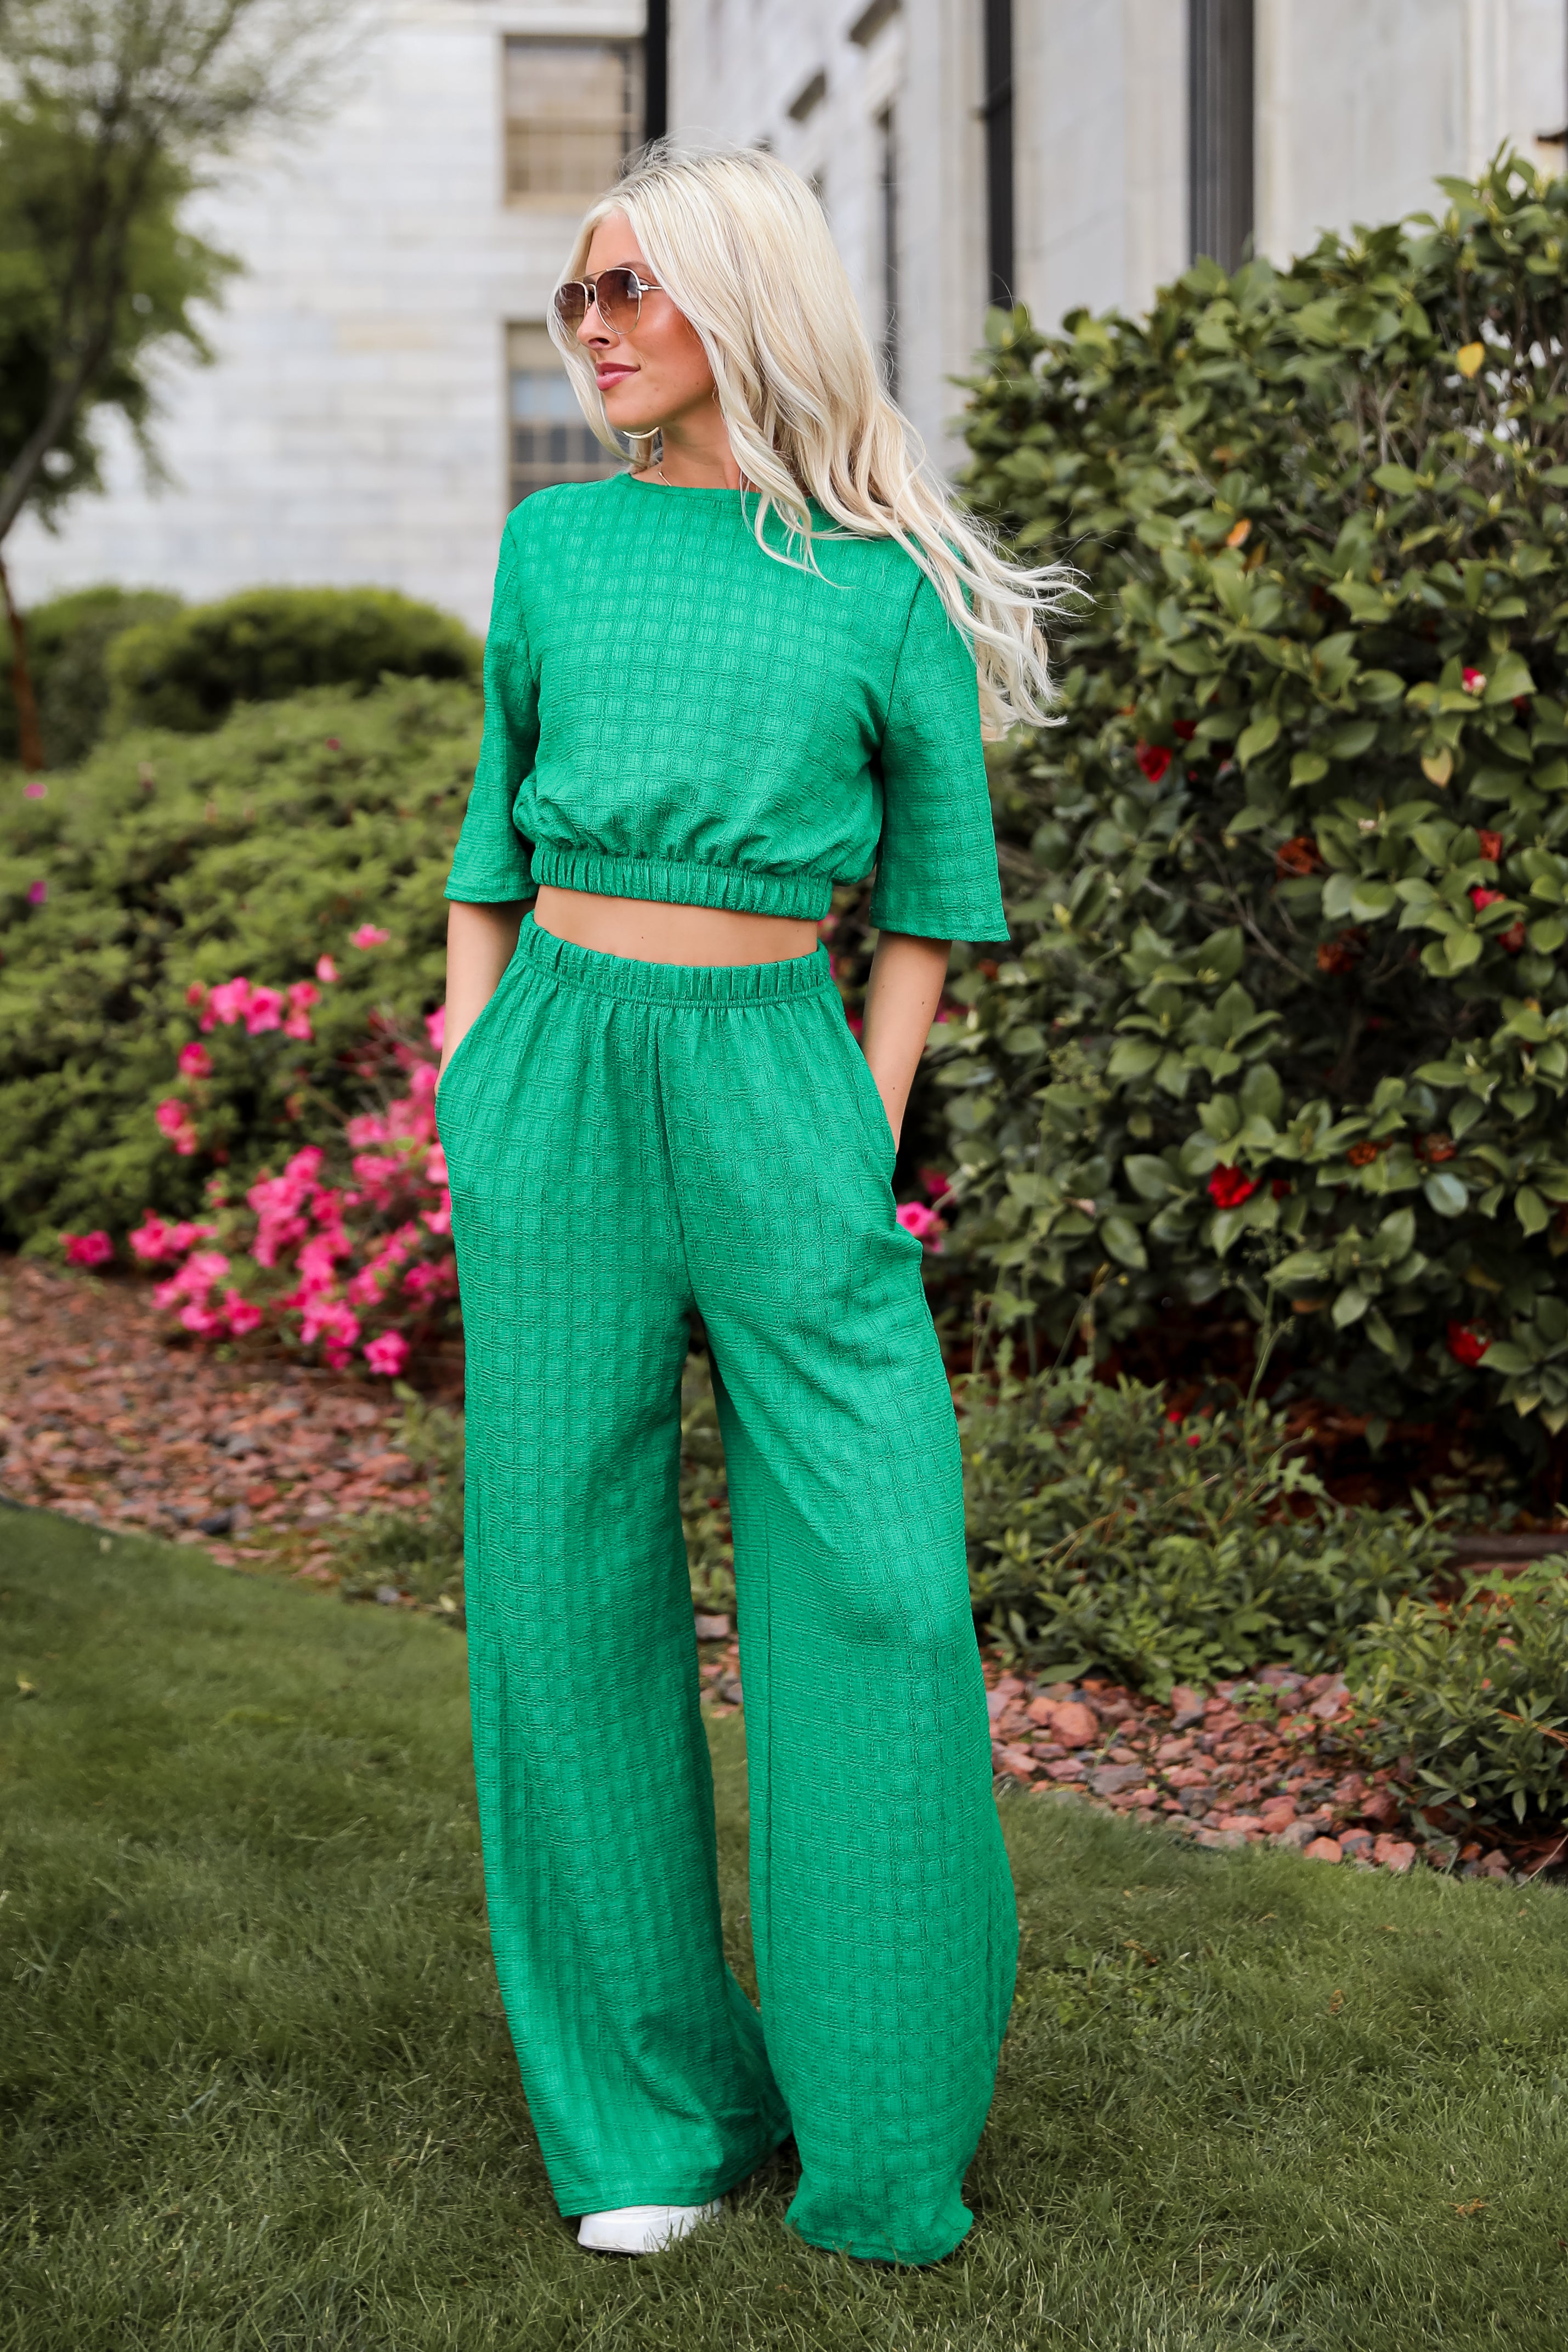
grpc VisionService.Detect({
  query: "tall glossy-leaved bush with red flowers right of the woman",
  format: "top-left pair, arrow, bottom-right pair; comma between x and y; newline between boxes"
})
936,160 -> 1568,1432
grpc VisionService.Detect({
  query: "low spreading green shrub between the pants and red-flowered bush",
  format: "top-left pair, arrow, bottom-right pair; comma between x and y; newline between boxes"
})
959,1357 -> 1448,1698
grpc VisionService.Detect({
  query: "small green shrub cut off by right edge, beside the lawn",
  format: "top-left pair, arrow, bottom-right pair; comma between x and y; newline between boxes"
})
1352,1562 -> 1568,1830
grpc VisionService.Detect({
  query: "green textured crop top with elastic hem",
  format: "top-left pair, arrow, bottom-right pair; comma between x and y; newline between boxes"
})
446,475 -> 1006,941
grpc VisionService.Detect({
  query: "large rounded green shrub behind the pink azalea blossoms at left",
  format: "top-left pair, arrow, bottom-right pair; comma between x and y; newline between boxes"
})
0,680 -> 479,1247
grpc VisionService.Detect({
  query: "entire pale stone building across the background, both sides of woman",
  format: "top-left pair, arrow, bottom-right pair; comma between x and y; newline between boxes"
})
7,0 -> 1568,626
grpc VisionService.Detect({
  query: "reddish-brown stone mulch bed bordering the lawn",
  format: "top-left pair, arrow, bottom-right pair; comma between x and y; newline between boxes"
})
0,1258 -> 1554,1877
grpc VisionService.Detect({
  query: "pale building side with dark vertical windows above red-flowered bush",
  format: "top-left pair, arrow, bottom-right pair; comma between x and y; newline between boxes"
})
670,0 -> 1568,456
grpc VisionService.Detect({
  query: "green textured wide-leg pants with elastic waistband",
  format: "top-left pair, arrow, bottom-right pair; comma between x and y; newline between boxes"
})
440,920 -> 1016,2263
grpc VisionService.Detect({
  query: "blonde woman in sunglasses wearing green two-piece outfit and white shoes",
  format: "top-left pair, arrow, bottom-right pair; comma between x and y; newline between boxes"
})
440,146 -> 1053,2263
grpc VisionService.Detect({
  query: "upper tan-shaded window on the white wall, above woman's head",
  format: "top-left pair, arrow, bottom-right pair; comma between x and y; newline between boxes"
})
506,38 -> 642,205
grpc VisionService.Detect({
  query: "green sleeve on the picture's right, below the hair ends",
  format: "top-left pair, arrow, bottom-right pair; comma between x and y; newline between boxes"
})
870,574 -> 1006,941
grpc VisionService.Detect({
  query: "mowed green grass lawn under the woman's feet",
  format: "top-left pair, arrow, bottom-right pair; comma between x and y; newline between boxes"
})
0,1512 -> 1568,2352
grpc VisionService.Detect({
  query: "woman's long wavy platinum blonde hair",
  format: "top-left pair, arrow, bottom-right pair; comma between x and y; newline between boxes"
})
550,139 -> 1077,736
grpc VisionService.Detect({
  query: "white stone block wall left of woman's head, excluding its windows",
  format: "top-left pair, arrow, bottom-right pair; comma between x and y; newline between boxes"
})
7,0 -> 642,628
